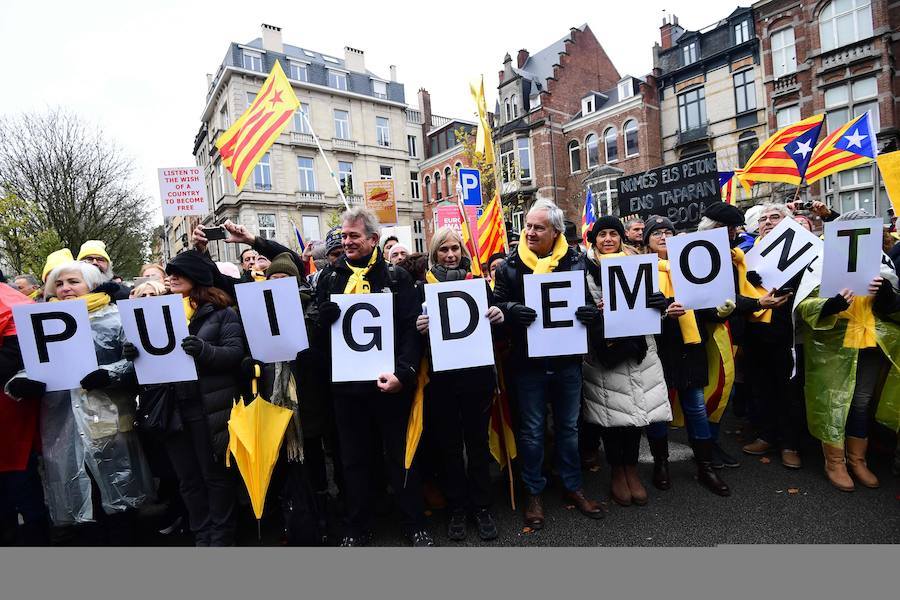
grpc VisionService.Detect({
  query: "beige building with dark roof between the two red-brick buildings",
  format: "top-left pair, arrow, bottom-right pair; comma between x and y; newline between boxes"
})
653,7 -> 769,209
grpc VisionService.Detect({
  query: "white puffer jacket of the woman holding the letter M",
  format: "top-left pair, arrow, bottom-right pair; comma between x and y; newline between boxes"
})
582,249 -> 672,427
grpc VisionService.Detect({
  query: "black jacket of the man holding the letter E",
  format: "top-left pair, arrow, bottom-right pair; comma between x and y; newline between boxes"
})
494,245 -> 594,369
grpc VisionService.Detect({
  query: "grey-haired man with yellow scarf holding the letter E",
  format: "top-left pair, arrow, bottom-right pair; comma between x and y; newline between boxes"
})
494,200 -> 603,529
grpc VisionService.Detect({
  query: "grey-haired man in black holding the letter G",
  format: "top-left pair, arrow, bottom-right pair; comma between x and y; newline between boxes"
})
313,208 -> 434,546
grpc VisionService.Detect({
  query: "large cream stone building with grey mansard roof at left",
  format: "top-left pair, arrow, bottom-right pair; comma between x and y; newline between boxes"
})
181,24 -> 423,261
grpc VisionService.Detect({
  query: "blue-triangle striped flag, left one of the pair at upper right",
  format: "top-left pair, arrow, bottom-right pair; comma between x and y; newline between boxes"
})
737,115 -> 825,194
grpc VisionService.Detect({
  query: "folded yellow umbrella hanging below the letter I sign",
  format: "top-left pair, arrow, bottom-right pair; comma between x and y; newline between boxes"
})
225,384 -> 293,519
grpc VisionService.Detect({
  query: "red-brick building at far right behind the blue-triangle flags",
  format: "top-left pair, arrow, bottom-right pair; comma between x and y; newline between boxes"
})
753,0 -> 900,217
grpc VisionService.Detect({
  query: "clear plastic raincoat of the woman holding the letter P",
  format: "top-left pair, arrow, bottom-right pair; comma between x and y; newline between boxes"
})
7,304 -> 153,525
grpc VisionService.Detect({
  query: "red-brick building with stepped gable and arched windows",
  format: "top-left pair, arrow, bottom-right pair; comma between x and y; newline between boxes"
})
494,24 -> 660,226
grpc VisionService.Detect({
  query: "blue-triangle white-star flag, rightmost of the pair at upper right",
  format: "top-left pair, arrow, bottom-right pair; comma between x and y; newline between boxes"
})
806,111 -> 878,183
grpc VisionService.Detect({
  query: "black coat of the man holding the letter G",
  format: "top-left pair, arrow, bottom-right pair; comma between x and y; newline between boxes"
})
309,249 -> 422,395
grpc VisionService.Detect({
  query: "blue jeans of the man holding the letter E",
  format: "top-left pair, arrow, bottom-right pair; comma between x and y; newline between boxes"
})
516,361 -> 582,495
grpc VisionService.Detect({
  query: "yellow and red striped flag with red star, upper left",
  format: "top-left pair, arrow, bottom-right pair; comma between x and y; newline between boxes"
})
216,60 -> 300,191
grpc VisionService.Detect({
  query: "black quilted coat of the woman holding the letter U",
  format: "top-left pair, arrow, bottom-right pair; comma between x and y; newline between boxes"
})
178,304 -> 247,457
